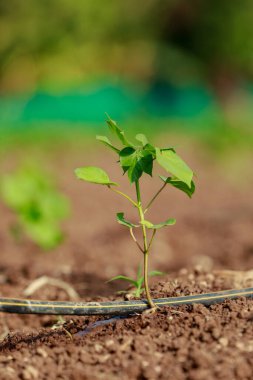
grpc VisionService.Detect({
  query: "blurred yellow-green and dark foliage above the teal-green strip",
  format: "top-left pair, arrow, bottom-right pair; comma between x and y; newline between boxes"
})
0,0 -> 253,94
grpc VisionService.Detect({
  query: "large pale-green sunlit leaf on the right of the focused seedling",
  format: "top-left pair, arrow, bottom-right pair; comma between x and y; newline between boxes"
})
156,148 -> 193,187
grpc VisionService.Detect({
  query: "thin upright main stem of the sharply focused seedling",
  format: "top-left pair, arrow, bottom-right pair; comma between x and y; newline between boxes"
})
135,180 -> 156,309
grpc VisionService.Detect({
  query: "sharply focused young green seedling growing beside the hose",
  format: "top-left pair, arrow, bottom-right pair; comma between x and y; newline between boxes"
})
75,116 -> 195,309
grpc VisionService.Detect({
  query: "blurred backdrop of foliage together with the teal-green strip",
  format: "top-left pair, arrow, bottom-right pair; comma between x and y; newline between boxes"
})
0,0 -> 253,133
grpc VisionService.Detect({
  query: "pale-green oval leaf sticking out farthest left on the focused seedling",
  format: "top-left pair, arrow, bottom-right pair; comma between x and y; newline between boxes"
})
75,166 -> 118,186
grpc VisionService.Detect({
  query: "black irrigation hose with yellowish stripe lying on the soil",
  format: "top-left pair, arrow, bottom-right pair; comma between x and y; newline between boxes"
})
0,288 -> 253,315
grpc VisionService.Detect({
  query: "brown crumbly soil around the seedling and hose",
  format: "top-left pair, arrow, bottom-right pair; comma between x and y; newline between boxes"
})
0,140 -> 253,380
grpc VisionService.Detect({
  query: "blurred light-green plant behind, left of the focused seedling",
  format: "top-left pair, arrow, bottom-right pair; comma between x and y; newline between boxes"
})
1,166 -> 69,250
